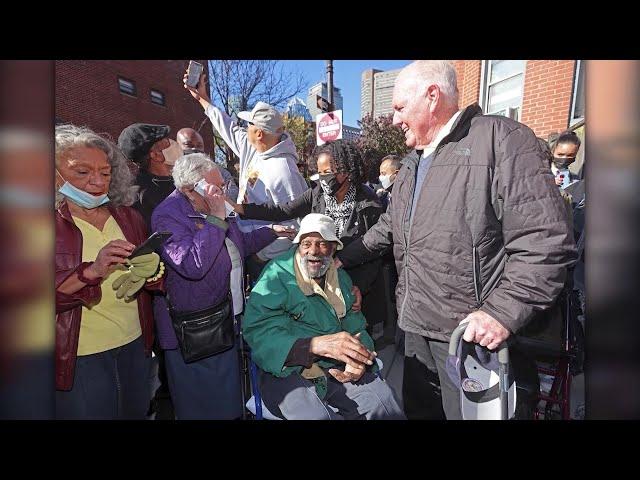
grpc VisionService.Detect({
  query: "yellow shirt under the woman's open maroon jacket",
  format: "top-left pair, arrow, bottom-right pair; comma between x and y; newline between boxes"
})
73,217 -> 142,355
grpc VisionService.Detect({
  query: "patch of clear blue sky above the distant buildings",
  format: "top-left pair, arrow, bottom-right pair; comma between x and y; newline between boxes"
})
282,60 -> 411,127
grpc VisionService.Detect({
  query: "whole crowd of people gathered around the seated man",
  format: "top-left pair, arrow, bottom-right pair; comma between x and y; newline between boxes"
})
55,61 -> 584,420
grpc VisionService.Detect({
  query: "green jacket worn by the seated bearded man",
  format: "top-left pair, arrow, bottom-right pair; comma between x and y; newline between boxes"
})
242,248 -> 377,377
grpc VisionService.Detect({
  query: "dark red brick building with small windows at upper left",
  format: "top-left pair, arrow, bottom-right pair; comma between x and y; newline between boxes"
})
55,60 -> 214,158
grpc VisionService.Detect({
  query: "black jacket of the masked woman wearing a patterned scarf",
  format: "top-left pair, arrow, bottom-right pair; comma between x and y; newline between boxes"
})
243,184 -> 383,295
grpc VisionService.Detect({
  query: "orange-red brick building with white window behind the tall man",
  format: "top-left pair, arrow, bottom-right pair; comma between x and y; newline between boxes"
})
453,60 -> 585,171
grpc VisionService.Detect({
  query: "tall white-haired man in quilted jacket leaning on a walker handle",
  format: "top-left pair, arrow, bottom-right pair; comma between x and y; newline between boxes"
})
338,61 -> 576,419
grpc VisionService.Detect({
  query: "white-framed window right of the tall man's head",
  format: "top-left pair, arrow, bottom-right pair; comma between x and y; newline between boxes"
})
482,60 -> 527,120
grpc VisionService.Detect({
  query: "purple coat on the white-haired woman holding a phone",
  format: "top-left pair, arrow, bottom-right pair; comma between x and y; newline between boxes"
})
151,190 -> 276,350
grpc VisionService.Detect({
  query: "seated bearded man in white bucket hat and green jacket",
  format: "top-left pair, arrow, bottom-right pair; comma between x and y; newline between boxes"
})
243,213 -> 405,420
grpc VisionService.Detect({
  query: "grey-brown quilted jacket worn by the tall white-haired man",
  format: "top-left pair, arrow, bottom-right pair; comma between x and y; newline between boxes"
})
338,105 -> 576,340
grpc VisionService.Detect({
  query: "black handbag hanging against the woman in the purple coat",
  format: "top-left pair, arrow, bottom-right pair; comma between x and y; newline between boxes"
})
167,295 -> 235,363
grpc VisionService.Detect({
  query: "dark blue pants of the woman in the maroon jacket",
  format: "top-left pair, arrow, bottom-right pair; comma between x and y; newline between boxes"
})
56,337 -> 150,420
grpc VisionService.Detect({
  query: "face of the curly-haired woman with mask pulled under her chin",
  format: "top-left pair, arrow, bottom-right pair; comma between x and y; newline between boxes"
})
56,146 -> 111,196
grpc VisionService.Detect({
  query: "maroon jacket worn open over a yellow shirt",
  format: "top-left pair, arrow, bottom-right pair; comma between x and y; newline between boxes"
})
56,202 -> 164,390
